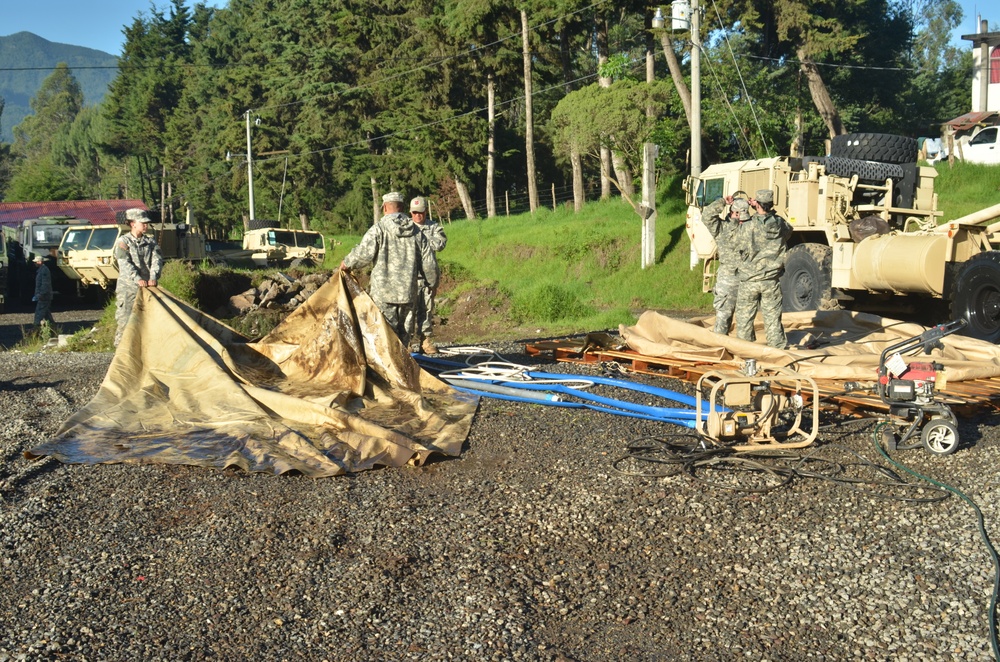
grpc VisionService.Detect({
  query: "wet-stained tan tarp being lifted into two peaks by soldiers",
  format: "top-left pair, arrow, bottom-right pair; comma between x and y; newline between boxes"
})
26,272 -> 478,477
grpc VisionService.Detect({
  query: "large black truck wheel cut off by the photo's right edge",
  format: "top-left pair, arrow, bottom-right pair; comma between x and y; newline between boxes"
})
951,251 -> 1000,343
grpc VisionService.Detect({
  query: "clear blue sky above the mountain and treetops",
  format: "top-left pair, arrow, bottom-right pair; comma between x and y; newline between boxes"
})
0,0 -> 1000,55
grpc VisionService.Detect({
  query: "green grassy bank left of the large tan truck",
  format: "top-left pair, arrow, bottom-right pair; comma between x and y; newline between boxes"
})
328,182 -> 711,335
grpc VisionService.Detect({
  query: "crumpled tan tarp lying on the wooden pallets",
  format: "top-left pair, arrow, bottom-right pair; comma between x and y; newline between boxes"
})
619,310 -> 1000,381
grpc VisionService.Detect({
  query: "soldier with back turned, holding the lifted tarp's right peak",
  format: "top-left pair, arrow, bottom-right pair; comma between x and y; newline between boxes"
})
340,192 -> 437,347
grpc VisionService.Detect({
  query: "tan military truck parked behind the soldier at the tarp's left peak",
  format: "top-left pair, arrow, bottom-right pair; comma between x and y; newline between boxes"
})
59,223 -> 206,290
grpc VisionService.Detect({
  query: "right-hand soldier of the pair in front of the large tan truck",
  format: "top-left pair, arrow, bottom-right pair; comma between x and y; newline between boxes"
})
736,189 -> 792,349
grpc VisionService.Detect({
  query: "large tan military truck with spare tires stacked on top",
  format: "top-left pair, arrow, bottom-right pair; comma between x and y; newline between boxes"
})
684,134 -> 1000,342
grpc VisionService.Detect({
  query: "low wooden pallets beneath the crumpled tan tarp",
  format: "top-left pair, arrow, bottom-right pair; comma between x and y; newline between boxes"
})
524,339 -> 1000,415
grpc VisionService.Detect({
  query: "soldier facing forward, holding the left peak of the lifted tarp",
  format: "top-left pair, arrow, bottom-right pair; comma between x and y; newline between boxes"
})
115,209 -> 163,347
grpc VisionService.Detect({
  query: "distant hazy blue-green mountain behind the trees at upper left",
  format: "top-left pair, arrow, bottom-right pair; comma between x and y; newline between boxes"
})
0,32 -> 118,143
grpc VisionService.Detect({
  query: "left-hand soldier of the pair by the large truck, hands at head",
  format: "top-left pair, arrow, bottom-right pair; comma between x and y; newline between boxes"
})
701,196 -> 750,335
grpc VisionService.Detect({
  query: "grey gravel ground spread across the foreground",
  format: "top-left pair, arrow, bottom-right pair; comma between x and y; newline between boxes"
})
0,342 -> 1000,661
